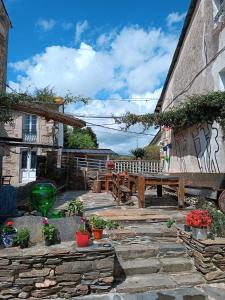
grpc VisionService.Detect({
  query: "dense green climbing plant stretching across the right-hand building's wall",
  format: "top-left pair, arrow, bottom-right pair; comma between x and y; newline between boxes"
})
115,91 -> 225,130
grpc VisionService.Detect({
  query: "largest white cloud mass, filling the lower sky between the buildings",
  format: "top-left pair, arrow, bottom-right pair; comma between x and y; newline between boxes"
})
9,22 -> 177,153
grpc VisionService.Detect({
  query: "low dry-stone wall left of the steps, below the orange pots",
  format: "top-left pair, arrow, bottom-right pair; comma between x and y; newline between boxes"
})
0,242 -> 115,299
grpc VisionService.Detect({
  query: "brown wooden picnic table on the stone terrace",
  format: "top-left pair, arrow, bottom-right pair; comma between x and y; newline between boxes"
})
129,174 -> 185,208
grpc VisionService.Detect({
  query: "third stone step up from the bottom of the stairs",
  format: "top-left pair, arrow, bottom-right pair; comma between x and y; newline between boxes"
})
115,242 -> 186,260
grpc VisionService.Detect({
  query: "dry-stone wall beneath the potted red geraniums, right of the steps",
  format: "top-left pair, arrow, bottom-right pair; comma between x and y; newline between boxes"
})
178,230 -> 225,282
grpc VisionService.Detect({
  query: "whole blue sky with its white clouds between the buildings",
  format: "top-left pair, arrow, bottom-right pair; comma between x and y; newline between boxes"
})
5,0 -> 189,153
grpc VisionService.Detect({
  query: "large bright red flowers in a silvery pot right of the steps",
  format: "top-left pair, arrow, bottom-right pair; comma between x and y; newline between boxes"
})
186,210 -> 212,240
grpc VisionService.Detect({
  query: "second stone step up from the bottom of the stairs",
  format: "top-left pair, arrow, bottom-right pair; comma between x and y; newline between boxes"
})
119,257 -> 194,276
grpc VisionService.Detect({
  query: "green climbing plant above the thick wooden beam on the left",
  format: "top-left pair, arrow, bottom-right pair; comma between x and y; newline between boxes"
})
0,87 -> 88,123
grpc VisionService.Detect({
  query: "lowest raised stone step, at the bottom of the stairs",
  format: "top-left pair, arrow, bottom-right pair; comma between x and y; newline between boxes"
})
115,273 -> 205,292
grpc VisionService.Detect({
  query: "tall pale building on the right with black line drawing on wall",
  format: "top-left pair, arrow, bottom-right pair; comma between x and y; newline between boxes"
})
156,0 -> 225,178
